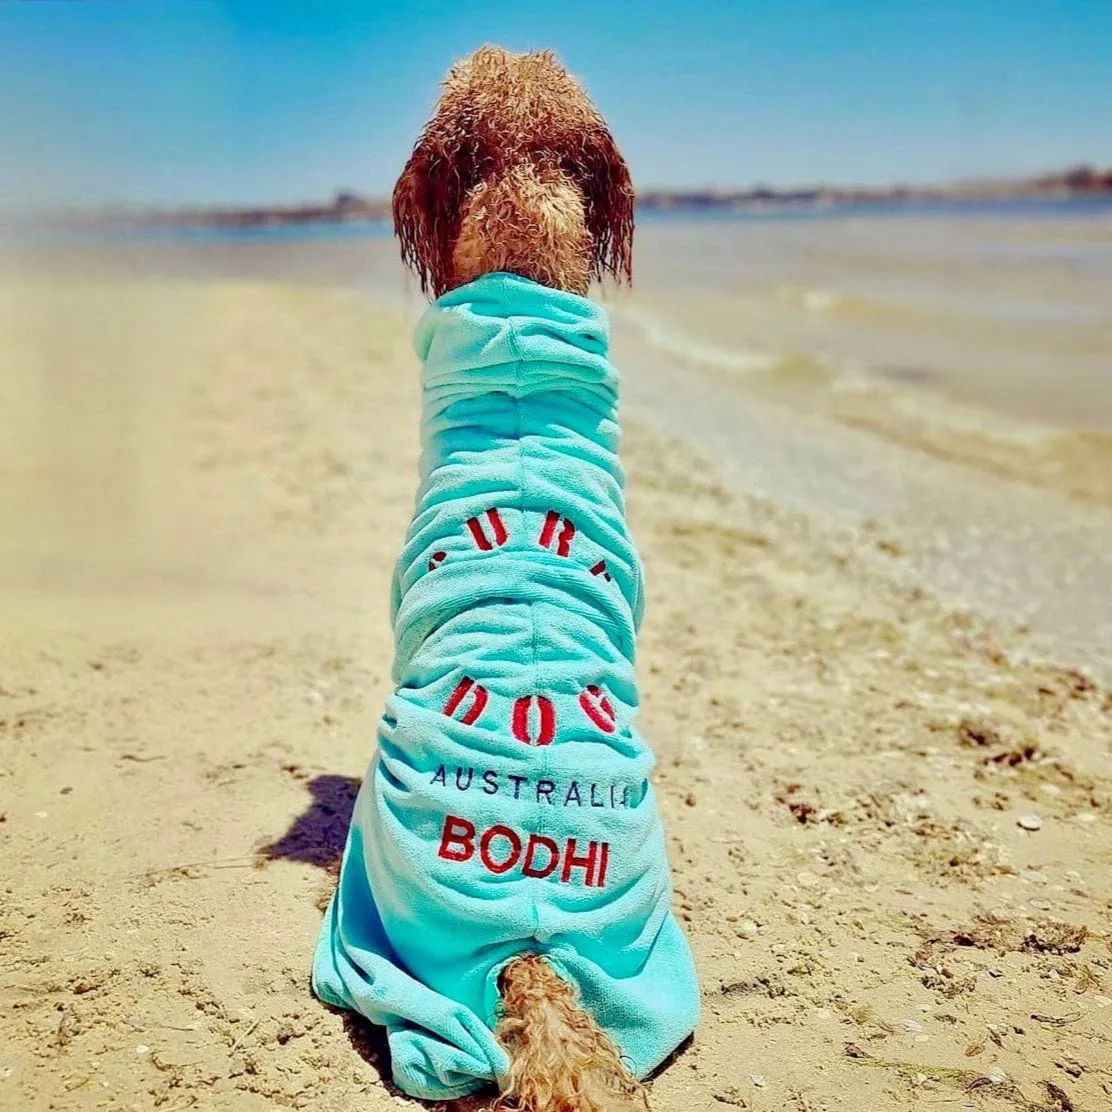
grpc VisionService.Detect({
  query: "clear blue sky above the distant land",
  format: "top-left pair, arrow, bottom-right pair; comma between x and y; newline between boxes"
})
0,0 -> 1112,205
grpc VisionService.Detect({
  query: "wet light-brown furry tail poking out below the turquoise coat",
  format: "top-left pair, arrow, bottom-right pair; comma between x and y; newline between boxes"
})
495,954 -> 649,1112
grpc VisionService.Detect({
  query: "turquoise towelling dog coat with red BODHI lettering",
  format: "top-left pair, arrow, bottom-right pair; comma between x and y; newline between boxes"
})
312,274 -> 698,1100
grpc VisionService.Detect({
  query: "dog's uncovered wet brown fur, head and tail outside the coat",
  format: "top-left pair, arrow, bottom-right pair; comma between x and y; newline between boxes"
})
394,47 -> 647,1112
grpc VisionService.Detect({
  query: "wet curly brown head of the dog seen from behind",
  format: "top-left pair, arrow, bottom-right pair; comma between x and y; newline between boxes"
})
394,47 -> 634,297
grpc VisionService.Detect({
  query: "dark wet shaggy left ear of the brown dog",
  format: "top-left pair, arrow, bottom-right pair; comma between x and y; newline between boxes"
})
394,117 -> 476,297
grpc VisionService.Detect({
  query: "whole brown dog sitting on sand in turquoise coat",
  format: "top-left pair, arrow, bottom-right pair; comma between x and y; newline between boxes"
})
312,47 -> 698,1112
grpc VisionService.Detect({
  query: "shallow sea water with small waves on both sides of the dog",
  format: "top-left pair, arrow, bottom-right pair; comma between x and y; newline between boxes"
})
8,198 -> 1112,504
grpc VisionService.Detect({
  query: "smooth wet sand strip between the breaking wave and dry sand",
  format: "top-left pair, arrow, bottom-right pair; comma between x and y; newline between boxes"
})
619,313 -> 1112,683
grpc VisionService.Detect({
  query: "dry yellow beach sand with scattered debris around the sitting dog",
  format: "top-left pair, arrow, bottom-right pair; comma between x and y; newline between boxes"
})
0,275 -> 1112,1112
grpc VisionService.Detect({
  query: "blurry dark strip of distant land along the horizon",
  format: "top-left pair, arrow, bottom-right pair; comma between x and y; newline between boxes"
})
8,167 -> 1112,228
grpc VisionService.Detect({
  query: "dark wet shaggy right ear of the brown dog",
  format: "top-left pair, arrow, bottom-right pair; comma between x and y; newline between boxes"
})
564,120 -> 634,284
